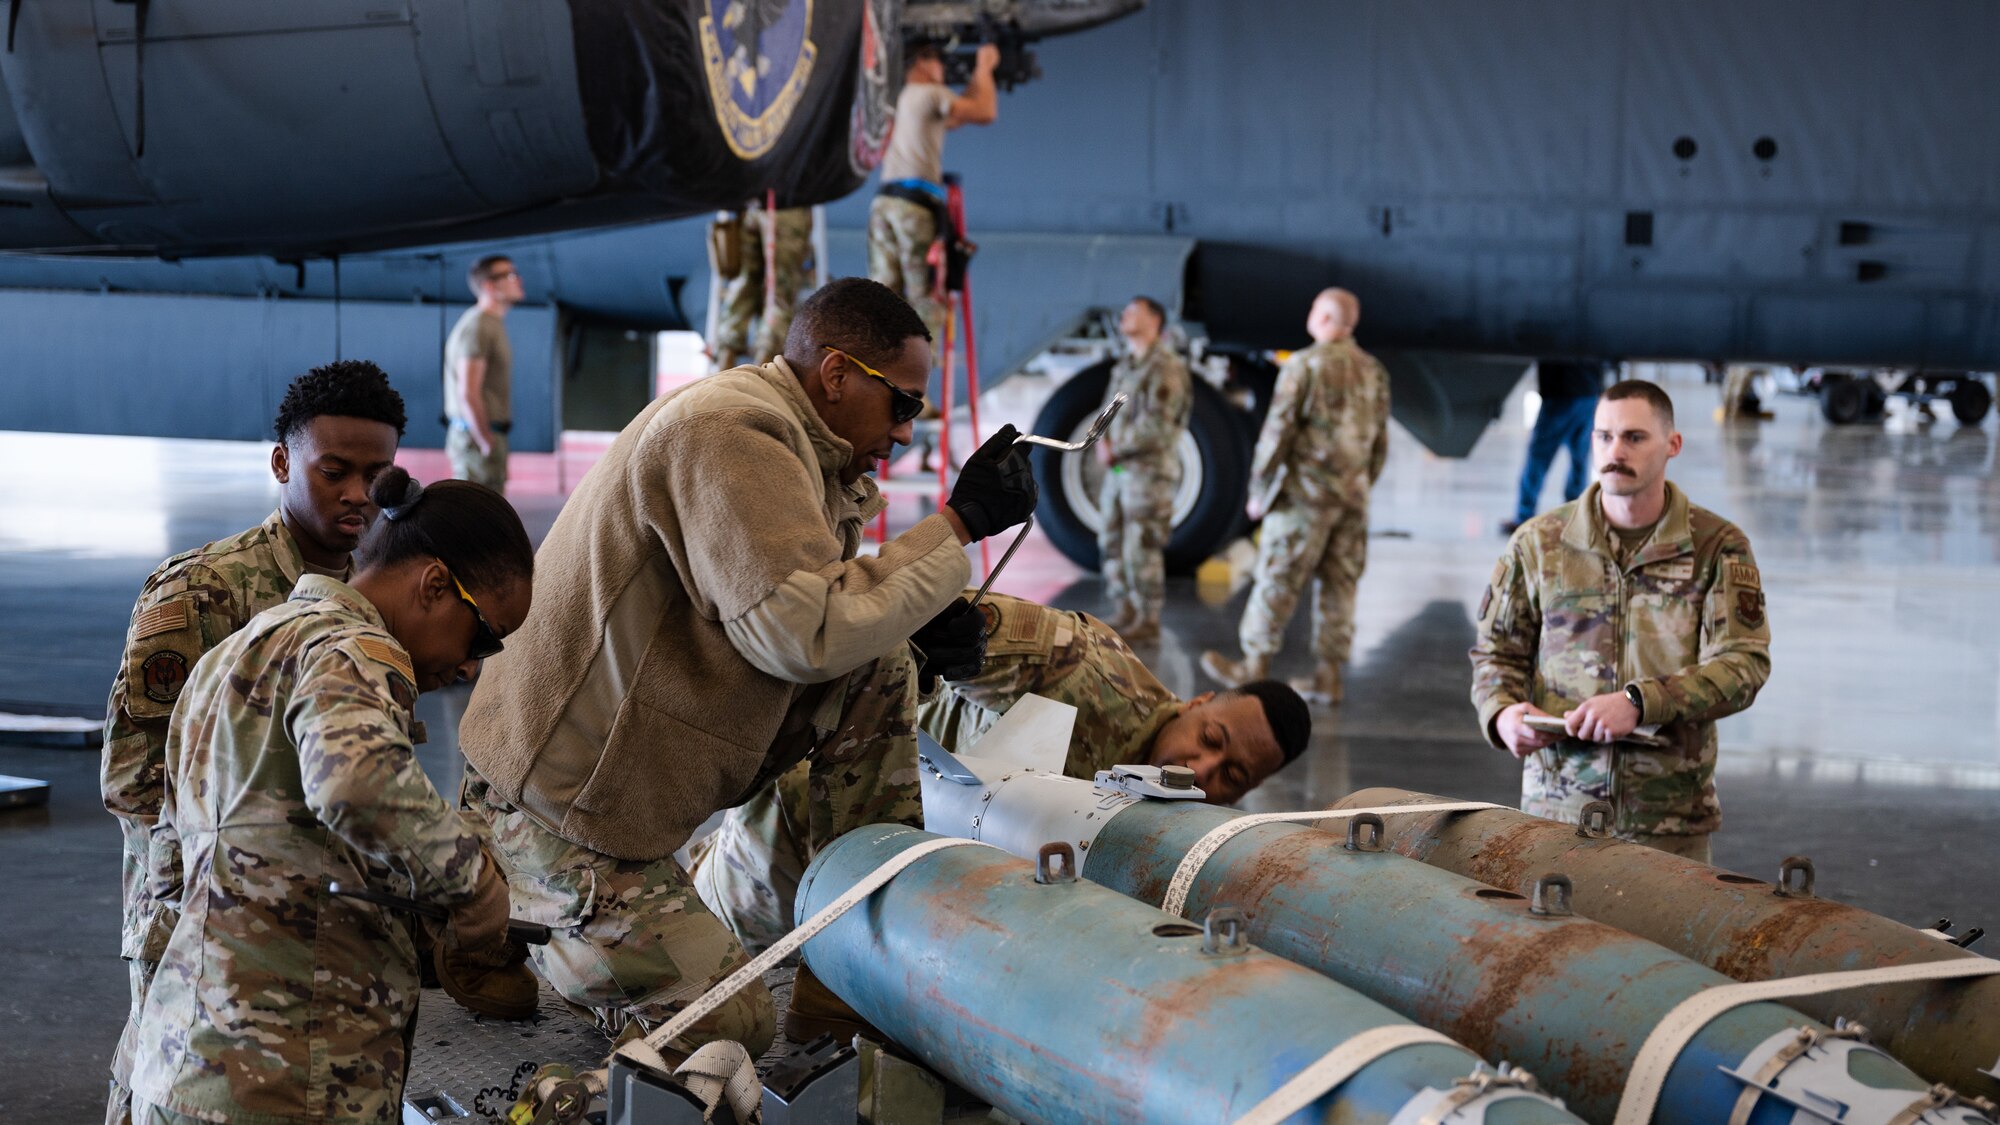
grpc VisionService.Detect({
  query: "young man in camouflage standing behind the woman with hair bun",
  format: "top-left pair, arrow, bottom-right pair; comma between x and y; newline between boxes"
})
98,360 -> 404,1123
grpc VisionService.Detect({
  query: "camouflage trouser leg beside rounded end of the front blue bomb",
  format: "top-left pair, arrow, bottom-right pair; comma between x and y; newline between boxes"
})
694,649 -> 924,953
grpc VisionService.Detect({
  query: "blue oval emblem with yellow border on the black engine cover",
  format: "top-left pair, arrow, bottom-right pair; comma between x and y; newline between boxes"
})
700,0 -> 820,160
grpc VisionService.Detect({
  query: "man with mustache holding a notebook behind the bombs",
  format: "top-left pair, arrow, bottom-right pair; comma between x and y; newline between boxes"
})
1472,378 -> 1770,863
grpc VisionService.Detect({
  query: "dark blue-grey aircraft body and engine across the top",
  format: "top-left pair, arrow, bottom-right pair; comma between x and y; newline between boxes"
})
0,0 -> 2000,448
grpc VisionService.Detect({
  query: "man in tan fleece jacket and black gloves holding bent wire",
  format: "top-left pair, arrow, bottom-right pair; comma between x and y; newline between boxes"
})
460,278 -> 1034,1055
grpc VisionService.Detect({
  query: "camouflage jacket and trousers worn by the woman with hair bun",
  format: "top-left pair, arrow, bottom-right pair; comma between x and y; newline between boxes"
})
132,575 -> 504,1125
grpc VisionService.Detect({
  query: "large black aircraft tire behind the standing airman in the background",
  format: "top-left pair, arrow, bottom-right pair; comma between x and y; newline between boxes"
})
1032,360 -> 1250,575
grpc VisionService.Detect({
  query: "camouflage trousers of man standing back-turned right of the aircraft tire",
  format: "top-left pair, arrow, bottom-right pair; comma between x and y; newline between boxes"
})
1238,498 -> 1368,669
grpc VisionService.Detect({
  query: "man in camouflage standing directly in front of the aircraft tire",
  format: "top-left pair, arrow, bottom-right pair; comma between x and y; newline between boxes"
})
1098,296 -> 1194,641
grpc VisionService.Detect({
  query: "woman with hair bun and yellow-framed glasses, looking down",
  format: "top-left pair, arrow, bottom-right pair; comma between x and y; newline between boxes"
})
132,468 -> 534,1125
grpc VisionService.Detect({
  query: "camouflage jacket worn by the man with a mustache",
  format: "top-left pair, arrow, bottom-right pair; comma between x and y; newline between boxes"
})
1472,484 -> 1770,835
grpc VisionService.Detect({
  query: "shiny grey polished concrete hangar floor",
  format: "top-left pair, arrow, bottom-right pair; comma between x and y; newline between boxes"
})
0,366 -> 2000,1121
